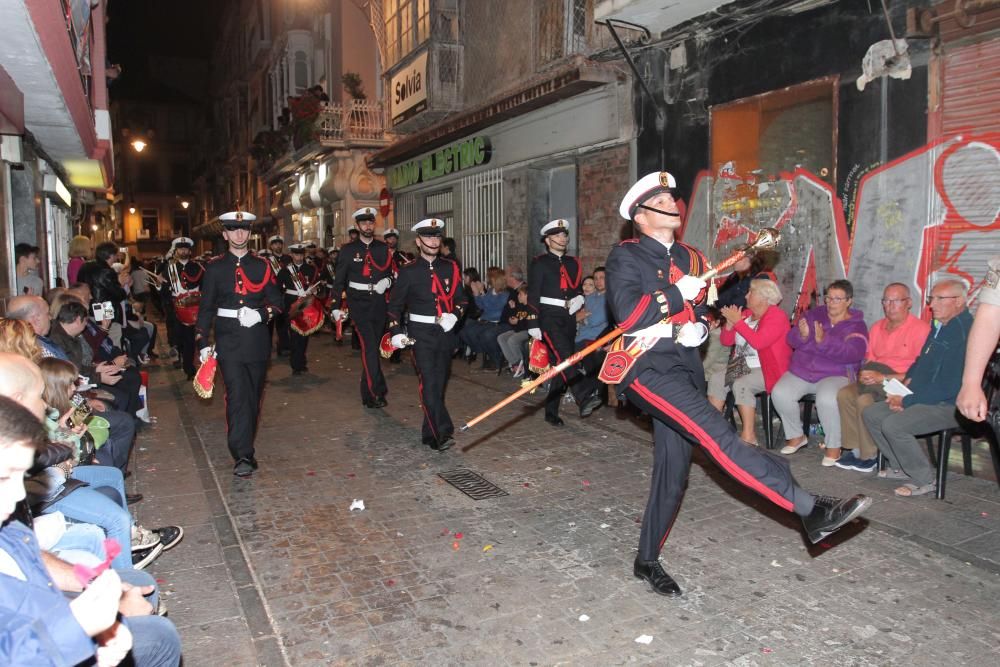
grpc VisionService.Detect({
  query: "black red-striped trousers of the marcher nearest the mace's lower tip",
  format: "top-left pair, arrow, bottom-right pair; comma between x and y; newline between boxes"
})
409,322 -> 458,445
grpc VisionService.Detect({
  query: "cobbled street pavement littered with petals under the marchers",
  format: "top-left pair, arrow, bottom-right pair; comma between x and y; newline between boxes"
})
136,334 -> 1000,667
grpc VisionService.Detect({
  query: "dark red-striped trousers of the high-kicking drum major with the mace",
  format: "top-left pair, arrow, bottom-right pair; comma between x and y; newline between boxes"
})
625,360 -> 813,561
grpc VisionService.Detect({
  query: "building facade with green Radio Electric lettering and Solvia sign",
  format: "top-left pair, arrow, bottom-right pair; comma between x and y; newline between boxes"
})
370,0 -> 635,271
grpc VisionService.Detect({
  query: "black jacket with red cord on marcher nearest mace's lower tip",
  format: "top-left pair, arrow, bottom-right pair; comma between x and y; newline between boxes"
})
387,257 -> 468,335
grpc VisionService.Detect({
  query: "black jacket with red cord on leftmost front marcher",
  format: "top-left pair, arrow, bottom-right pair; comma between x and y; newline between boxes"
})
195,251 -> 282,361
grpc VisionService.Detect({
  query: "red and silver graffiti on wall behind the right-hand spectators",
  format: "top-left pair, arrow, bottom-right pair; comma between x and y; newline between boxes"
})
684,133 -> 1000,321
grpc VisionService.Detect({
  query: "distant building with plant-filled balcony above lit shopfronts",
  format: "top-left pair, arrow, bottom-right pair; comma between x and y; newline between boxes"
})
194,0 -> 388,247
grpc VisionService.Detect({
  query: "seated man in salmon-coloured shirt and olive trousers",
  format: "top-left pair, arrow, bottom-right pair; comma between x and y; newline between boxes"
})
825,283 -> 930,472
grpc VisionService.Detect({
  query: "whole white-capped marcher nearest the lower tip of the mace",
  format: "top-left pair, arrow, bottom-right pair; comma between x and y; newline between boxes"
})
389,218 -> 466,451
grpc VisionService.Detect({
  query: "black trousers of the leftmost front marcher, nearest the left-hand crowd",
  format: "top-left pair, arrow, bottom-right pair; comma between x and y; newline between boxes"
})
219,354 -> 267,461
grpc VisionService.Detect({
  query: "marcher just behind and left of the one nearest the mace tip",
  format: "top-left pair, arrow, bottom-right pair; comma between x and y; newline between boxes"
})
332,207 -> 392,408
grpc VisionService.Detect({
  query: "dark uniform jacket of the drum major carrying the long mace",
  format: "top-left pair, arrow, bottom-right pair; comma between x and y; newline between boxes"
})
607,235 -> 708,387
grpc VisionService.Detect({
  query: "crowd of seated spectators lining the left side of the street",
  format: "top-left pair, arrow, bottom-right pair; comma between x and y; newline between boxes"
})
0,237 -> 183,665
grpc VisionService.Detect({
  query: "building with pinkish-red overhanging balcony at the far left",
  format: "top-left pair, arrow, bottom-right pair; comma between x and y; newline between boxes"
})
0,0 -> 114,299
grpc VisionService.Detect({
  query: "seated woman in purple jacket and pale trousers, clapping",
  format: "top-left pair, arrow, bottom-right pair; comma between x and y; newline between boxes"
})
771,280 -> 868,466
